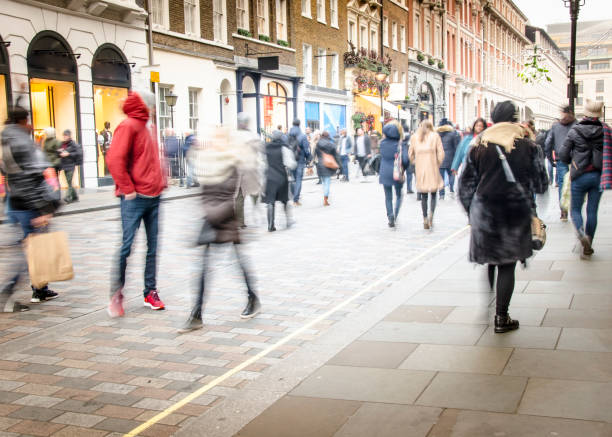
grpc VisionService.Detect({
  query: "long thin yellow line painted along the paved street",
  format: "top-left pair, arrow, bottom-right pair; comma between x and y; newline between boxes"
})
124,226 -> 469,437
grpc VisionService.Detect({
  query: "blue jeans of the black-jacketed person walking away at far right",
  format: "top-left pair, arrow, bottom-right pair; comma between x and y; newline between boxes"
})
568,171 -> 601,240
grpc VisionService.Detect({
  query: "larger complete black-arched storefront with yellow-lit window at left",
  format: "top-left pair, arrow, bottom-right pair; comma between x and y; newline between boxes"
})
27,31 -> 81,187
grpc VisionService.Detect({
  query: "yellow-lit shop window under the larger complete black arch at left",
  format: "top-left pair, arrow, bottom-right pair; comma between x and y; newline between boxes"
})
30,78 -> 81,188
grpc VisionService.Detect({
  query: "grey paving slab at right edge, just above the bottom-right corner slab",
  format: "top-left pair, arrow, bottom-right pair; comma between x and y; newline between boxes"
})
518,378 -> 612,423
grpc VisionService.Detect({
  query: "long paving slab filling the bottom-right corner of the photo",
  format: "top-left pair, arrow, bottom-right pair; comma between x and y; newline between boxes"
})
427,409 -> 612,437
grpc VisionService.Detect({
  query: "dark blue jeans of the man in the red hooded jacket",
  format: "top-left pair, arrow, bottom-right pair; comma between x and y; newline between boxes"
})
111,196 -> 160,297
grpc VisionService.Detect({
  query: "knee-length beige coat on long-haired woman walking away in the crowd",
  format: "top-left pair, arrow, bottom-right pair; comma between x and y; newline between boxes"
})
408,132 -> 444,193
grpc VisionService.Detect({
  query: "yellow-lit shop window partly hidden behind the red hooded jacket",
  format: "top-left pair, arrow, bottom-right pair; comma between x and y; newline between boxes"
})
93,85 -> 128,178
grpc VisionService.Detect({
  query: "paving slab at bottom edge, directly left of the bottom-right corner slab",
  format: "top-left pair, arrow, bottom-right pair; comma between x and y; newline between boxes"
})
334,403 -> 442,437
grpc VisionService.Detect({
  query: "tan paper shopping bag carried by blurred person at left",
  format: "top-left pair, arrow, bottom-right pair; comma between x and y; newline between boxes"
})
25,232 -> 74,288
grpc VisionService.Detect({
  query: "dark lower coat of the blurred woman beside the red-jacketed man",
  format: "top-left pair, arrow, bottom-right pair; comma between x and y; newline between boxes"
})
202,169 -> 240,244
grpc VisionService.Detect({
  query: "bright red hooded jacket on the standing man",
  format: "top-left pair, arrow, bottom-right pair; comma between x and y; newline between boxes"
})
106,92 -> 166,196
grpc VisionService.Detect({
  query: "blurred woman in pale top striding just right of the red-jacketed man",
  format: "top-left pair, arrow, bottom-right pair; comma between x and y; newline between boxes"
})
180,126 -> 260,333
